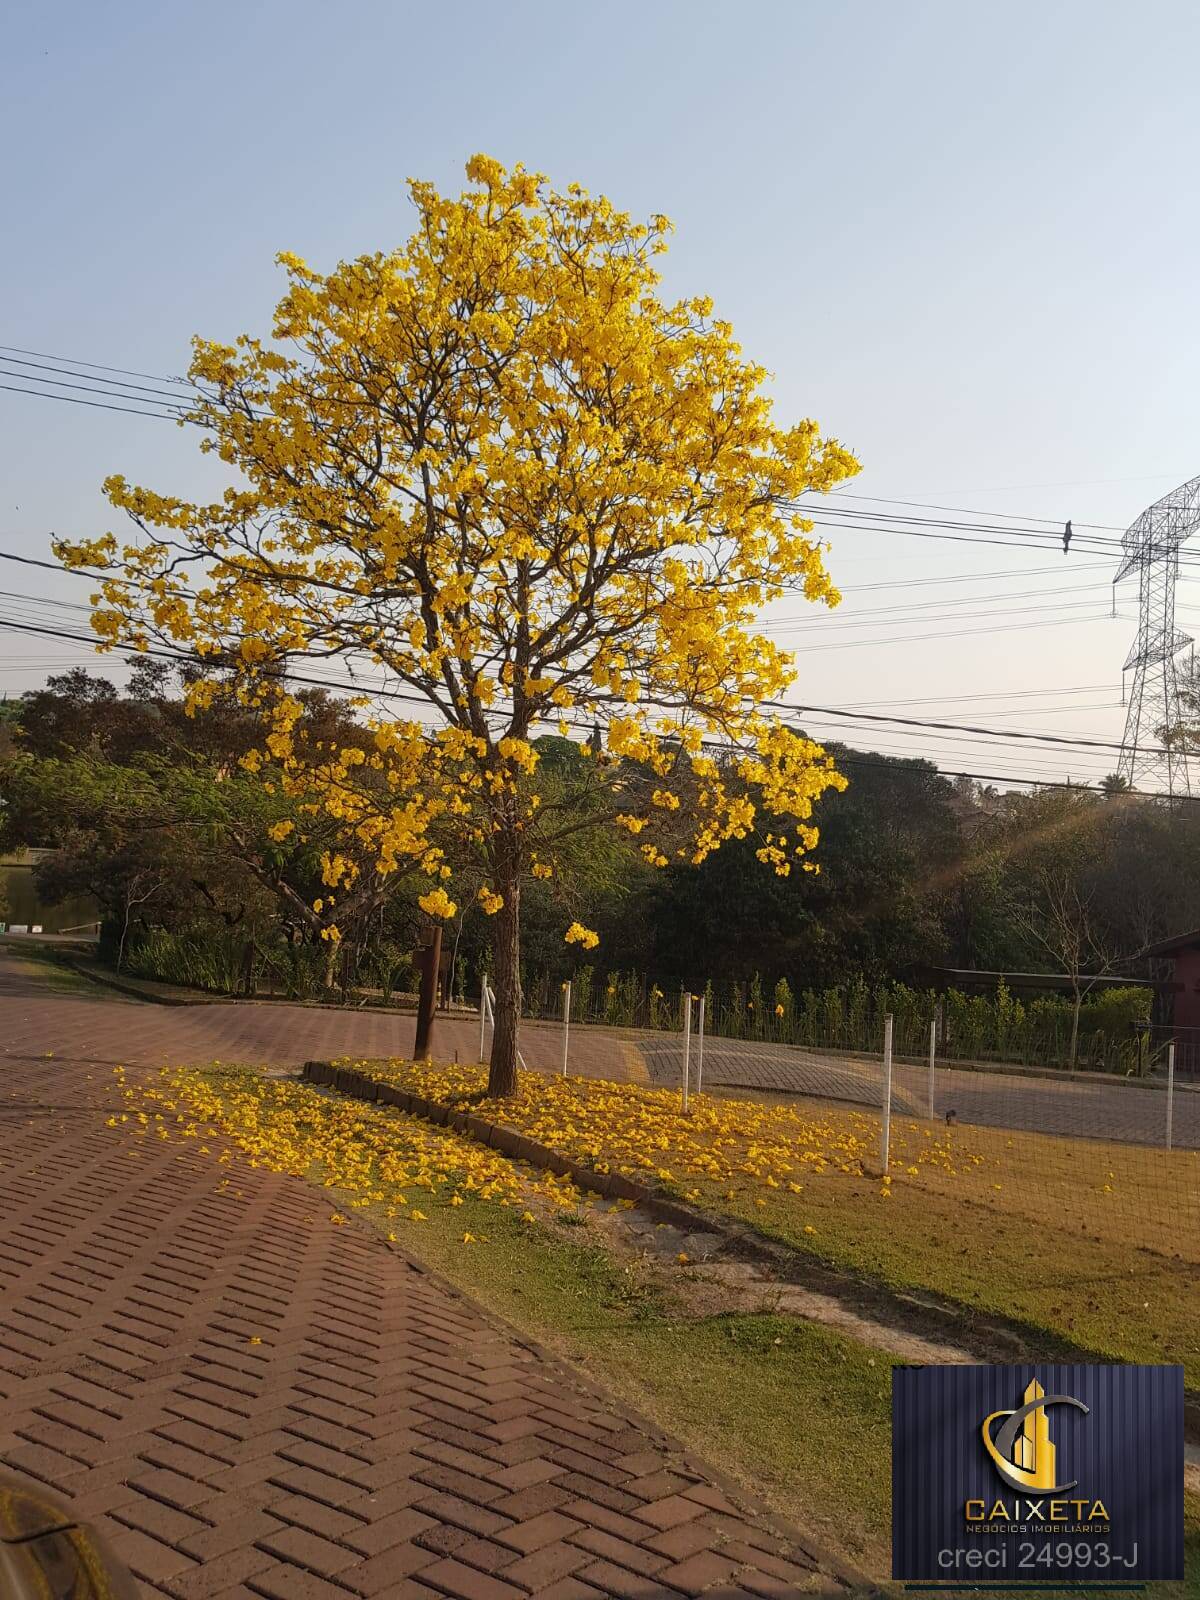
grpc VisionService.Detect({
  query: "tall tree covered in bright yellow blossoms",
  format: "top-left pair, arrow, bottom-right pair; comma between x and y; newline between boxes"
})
58,157 -> 856,1094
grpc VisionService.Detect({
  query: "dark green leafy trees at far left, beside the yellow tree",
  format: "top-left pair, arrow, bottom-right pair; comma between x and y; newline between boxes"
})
0,672 -> 414,987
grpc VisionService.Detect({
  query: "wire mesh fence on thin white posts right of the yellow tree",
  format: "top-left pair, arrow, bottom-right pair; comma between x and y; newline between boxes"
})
492,976 -> 1200,1292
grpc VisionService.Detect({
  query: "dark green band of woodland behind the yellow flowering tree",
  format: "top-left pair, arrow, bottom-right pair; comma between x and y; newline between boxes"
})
0,674 -> 1200,1059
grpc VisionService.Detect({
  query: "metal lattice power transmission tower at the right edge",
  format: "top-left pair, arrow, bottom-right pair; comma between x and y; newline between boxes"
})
1114,478 -> 1200,795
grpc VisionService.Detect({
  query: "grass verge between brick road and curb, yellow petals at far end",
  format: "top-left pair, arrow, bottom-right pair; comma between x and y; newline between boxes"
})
170,1069 -> 1200,1600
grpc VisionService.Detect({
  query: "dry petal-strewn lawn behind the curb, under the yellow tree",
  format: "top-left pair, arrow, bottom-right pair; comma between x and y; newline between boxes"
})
345,1061 -> 1200,1394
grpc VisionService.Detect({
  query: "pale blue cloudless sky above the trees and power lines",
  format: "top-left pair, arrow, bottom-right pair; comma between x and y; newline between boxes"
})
0,0 -> 1200,776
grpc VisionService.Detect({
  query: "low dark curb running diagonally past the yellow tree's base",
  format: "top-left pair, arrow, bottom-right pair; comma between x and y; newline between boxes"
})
301,1061 -> 1200,1443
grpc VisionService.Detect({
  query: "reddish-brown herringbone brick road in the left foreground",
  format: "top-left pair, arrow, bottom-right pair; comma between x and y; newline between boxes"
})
0,955 -> 843,1600
